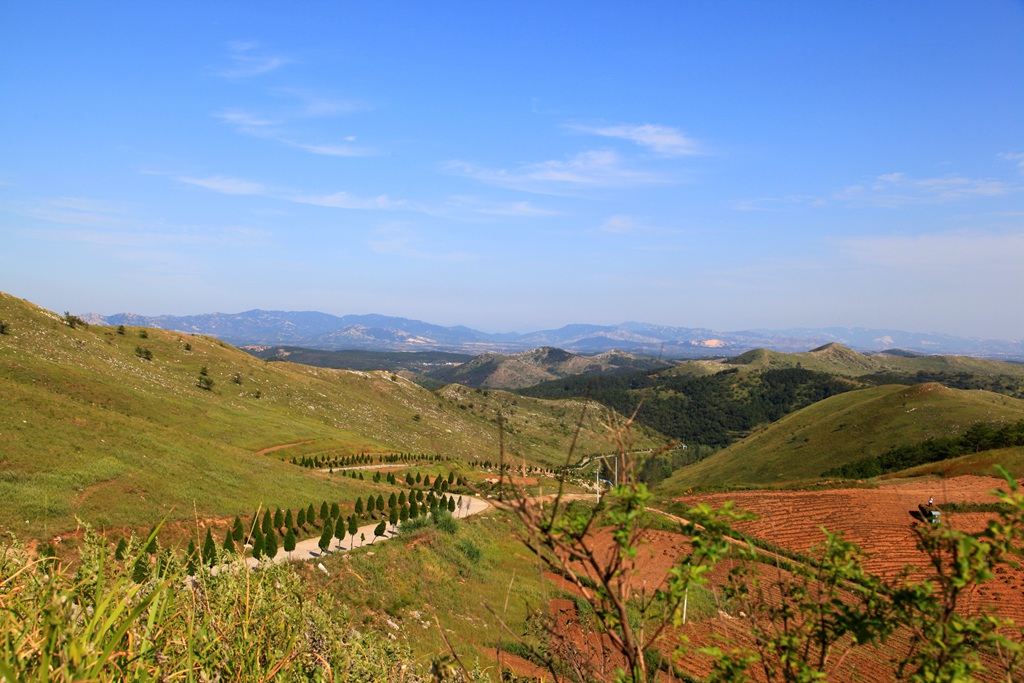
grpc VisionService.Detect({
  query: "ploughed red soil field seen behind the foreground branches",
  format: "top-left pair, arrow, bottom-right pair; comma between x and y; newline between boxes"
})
505,476 -> 1024,681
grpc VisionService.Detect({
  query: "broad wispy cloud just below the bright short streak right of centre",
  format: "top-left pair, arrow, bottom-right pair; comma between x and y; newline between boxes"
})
443,151 -> 666,195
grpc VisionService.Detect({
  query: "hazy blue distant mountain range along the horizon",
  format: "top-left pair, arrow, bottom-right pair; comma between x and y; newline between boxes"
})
82,309 -> 1024,360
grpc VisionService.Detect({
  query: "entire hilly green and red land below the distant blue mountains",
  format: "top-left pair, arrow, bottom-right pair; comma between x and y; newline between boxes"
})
0,293 -> 1024,681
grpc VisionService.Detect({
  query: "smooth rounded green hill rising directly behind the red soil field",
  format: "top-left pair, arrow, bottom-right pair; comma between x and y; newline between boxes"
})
663,383 -> 1024,493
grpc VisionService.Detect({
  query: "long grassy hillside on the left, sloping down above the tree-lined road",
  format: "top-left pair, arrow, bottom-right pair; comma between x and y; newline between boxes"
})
0,293 -> 647,537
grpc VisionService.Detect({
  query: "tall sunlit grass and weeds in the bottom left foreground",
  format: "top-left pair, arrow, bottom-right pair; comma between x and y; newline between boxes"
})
0,531 -> 481,683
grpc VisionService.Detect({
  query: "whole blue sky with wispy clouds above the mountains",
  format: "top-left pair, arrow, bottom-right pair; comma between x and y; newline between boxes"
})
0,0 -> 1024,339
